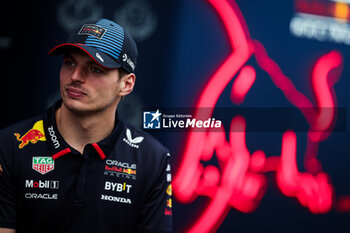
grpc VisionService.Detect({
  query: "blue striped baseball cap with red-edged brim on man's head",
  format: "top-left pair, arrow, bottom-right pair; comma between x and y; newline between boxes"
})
49,19 -> 137,73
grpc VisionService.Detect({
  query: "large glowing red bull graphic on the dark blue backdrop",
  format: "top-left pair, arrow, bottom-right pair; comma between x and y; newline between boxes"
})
173,0 -> 349,233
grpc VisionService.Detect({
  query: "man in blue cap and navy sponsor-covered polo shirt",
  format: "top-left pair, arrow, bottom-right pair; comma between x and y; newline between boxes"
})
0,19 -> 172,233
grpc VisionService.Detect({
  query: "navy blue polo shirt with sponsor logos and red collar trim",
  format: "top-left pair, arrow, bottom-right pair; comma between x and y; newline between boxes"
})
0,102 -> 172,233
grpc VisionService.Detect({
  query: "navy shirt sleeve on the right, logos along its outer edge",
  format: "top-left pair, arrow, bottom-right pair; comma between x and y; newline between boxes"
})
137,151 -> 172,233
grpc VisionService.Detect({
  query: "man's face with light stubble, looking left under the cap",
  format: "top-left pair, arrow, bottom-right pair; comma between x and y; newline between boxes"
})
60,49 -> 122,114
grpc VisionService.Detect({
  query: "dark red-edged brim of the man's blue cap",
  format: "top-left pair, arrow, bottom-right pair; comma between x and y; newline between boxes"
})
49,43 -> 122,69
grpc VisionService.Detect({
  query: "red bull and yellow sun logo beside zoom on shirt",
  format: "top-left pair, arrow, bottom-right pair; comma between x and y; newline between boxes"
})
14,120 -> 46,149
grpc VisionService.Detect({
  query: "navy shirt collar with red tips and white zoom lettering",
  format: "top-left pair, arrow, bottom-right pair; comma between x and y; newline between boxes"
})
44,100 -> 122,159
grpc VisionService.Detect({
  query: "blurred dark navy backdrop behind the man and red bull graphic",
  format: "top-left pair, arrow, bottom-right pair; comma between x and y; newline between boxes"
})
0,0 -> 350,233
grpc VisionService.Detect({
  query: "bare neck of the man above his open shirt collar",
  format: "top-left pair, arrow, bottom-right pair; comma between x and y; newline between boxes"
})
56,103 -> 115,153
